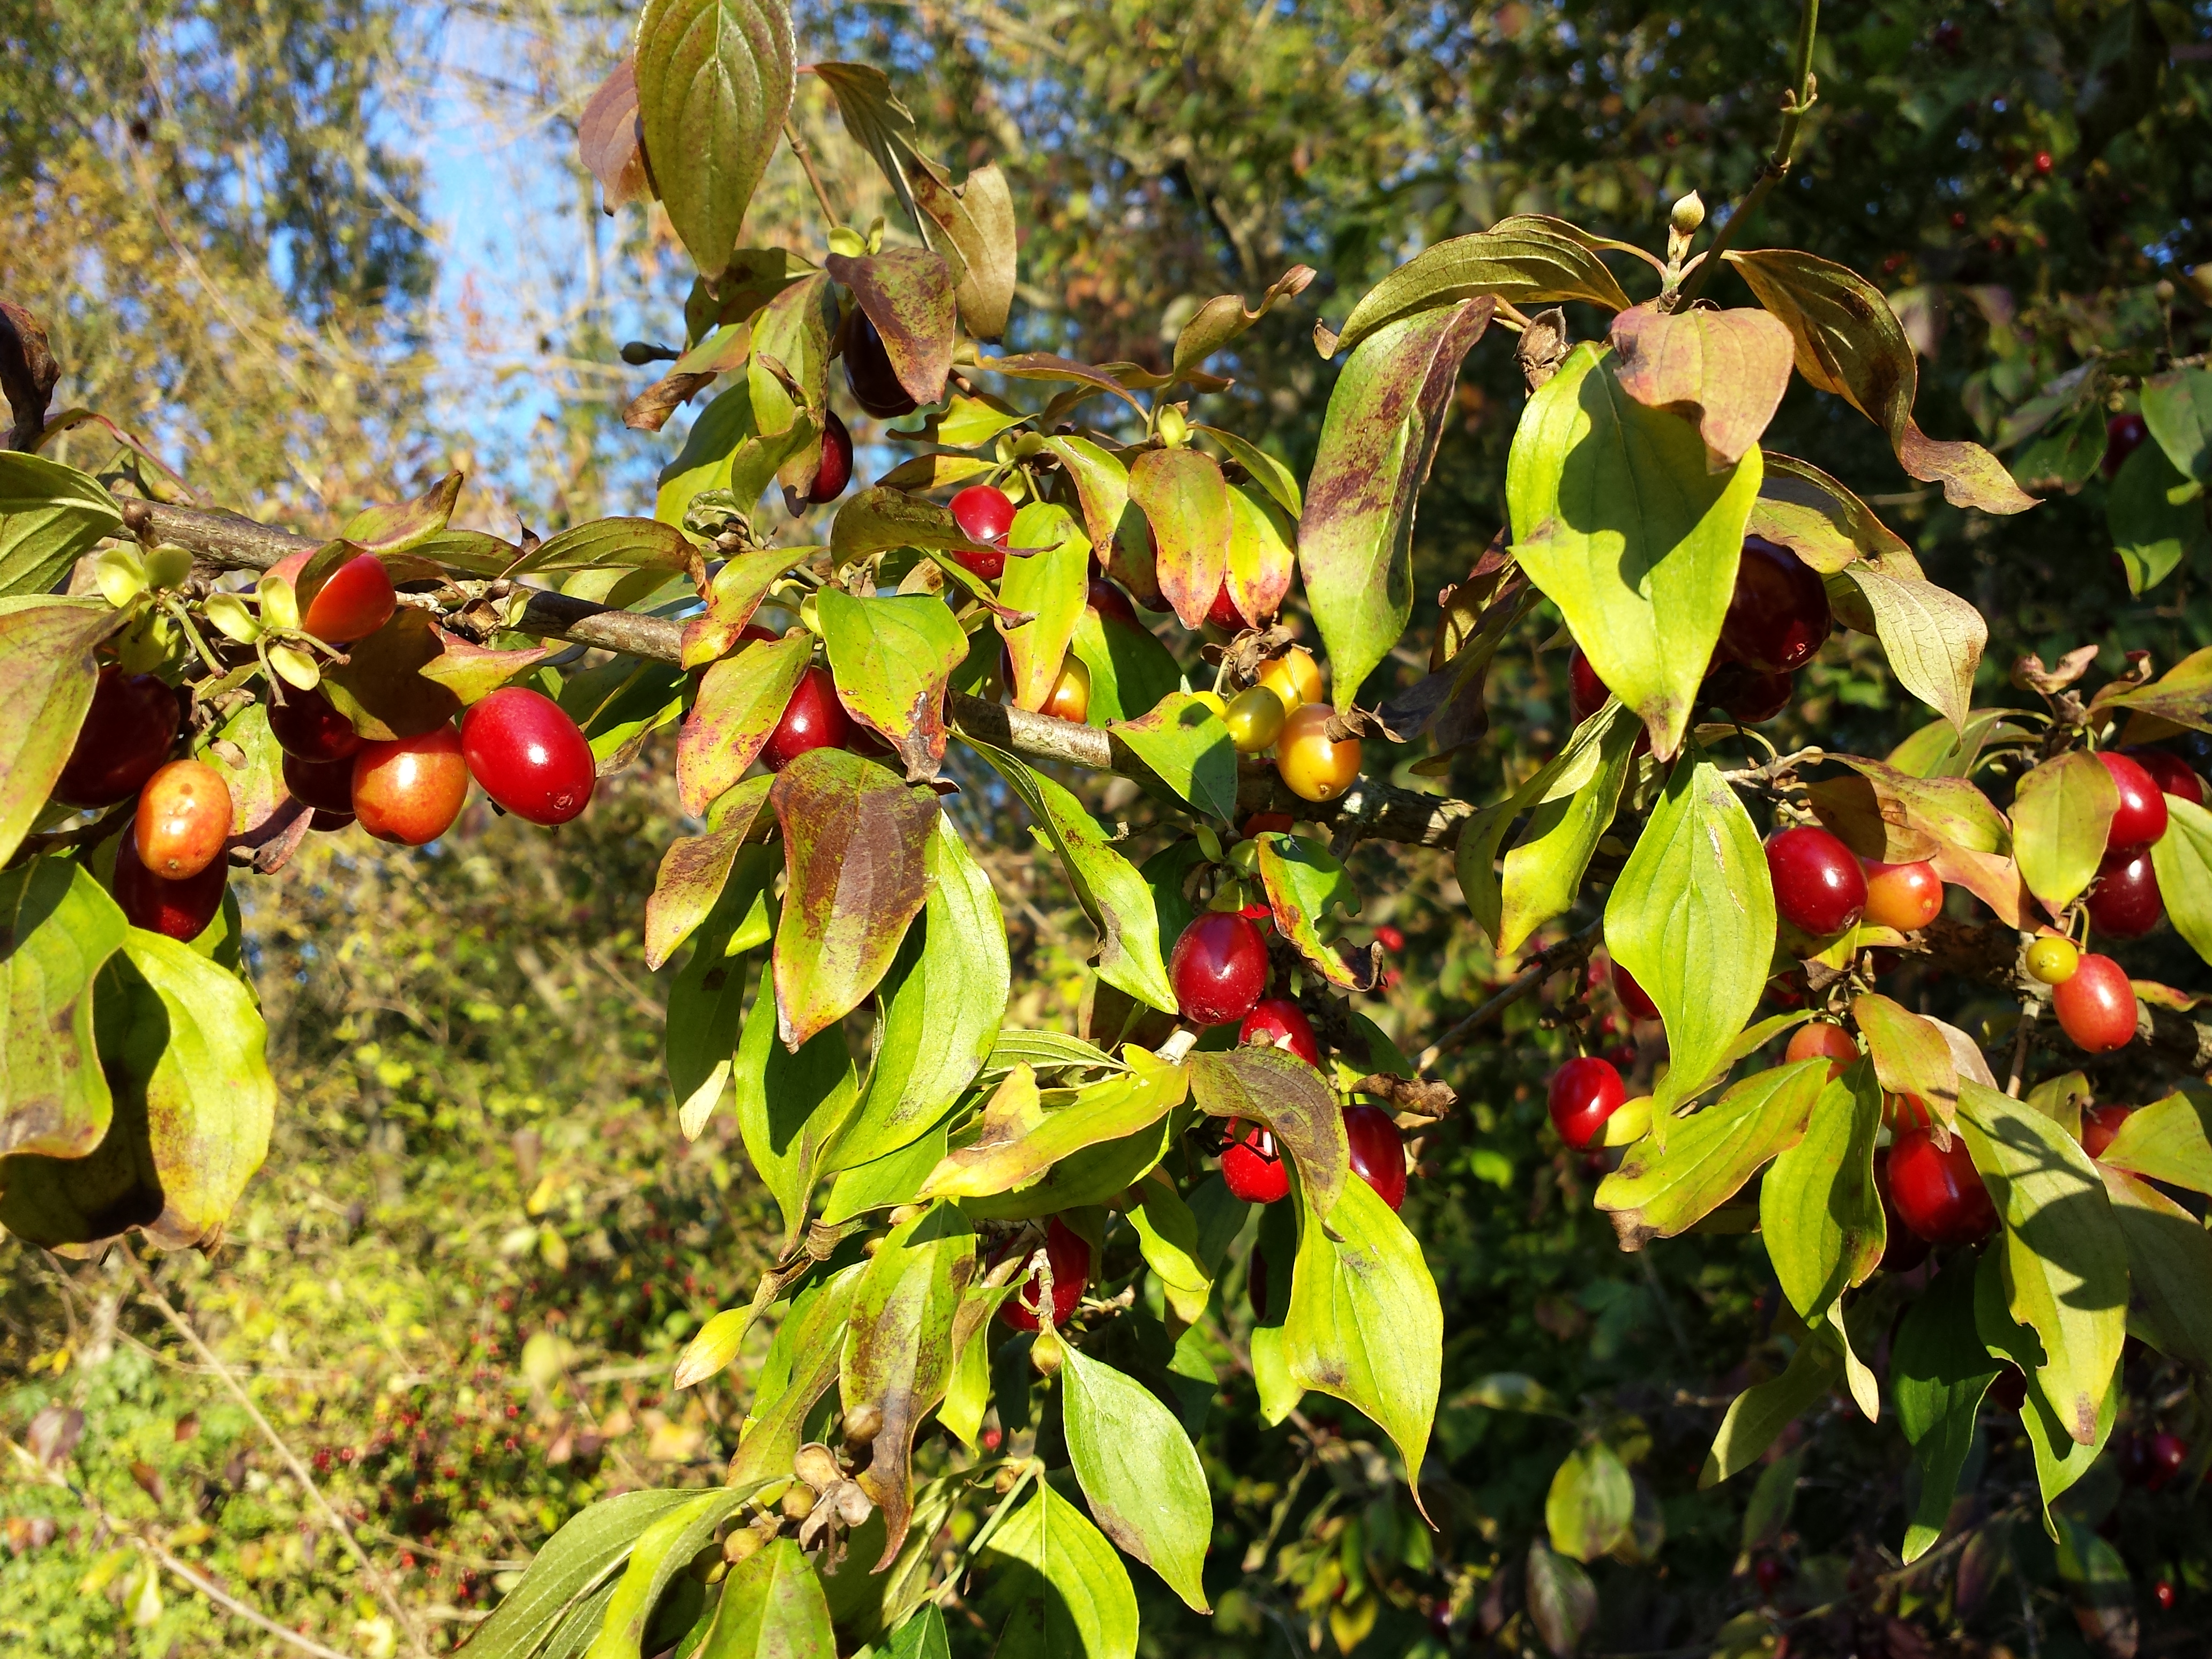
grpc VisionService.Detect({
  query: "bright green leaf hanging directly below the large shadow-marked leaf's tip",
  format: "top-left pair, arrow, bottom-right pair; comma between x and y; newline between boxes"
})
1601,752 -> 1774,1119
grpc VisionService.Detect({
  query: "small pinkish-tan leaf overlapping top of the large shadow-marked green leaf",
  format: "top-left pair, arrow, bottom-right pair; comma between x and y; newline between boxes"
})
1612,303 -> 1790,471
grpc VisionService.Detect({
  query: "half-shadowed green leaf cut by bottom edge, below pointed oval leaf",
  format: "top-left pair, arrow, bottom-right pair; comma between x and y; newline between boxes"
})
982,1480 -> 1137,1659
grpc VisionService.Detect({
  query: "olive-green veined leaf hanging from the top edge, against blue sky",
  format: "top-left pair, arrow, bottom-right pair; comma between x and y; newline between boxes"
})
635,0 -> 798,281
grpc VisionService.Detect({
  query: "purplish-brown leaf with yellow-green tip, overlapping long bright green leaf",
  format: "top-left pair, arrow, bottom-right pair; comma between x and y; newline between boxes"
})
767,750 -> 938,1051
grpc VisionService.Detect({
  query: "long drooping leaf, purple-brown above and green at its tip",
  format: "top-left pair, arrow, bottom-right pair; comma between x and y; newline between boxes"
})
1291,298 -> 1504,710
